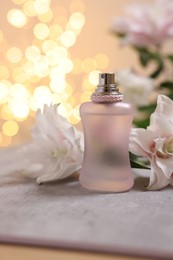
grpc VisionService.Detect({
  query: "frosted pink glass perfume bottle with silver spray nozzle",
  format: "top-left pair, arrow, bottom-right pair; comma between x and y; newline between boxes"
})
79,73 -> 134,192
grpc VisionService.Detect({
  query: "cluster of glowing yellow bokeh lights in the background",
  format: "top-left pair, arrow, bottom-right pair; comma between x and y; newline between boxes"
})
0,0 -> 109,147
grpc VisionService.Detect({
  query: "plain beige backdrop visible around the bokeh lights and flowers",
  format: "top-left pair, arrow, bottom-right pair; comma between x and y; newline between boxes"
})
0,0 -> 172,146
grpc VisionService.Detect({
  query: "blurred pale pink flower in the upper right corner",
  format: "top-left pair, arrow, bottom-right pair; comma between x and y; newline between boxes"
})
113,0 -> 173,48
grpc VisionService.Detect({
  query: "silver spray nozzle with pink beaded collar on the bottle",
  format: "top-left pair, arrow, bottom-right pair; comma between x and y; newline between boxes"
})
91,73 -> 123,103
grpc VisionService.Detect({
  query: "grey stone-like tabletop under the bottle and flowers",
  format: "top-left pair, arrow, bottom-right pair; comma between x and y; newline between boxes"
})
0,170 -> 173,259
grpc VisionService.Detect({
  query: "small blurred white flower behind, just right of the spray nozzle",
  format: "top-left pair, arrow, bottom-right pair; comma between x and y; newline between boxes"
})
117,69 -> 154,106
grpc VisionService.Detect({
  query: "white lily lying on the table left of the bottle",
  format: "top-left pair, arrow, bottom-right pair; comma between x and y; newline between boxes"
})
0,105 -> 84,184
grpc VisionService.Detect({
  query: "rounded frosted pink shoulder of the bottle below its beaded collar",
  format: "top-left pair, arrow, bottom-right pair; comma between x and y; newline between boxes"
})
80,101 -> 134,114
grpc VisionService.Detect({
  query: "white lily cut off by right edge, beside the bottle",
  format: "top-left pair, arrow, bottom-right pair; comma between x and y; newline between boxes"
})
129,95 -> 173,190
